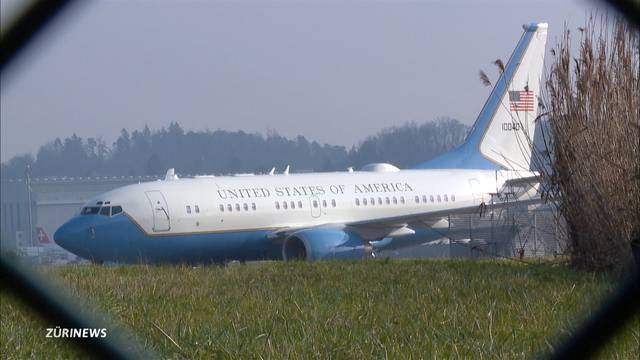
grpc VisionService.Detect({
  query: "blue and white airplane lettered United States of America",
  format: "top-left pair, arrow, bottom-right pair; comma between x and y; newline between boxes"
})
54,23 -> 548,263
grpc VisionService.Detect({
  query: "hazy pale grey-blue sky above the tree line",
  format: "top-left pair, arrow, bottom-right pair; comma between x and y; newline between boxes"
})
1,0 -> 595,161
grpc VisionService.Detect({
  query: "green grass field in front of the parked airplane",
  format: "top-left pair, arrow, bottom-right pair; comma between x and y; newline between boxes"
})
0,260 -> 640,359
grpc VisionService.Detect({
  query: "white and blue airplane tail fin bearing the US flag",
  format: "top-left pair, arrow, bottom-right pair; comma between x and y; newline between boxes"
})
416,23 -> 548,170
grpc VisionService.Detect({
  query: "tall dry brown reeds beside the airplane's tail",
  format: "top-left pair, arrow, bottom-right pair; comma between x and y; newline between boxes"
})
542,16 -> 640,269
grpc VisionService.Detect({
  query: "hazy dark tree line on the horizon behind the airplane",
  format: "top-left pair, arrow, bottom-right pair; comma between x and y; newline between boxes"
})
1,118 -> 468,178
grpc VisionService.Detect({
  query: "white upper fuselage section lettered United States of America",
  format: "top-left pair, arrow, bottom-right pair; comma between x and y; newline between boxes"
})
101,170 -> 506,235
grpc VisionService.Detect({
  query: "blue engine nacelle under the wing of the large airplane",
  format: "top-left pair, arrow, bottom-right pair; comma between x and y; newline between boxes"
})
282,229 -> 370,261
